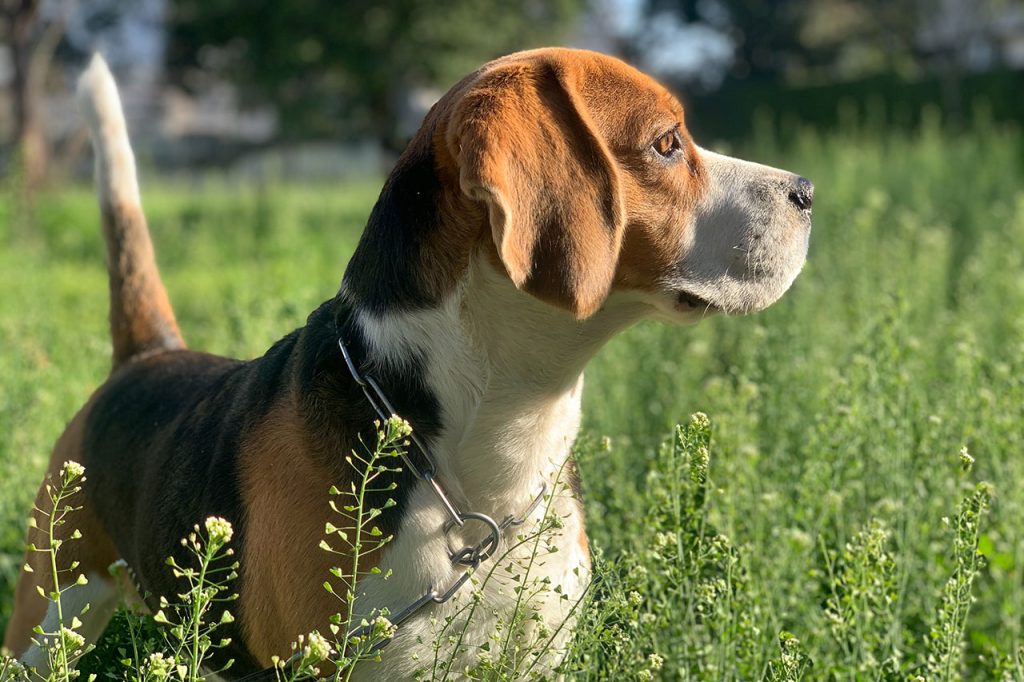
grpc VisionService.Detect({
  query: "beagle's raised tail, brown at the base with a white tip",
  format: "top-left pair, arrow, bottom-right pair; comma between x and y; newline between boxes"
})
78,54 -> 185,368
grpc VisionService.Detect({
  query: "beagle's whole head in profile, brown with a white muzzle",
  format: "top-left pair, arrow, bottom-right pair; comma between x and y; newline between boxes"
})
444,49 -> 813,321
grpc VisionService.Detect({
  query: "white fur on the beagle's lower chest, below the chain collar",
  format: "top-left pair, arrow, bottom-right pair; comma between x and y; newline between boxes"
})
355,456 -> 590,680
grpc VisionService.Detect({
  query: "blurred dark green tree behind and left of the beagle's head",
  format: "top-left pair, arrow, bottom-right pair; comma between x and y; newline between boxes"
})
168,0 -> 586,150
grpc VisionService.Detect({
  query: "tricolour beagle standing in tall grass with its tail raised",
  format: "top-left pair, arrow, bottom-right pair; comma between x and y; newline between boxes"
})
4,48 -> 813,680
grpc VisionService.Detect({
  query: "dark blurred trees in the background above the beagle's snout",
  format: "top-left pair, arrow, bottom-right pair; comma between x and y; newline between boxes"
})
618,0 -> 1024,136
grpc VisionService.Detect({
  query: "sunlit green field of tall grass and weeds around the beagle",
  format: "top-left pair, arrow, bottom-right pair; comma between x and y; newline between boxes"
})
0,117 -> 1024,680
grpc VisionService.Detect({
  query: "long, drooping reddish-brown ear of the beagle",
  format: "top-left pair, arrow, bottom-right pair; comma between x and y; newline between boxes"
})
446,62 -> 625,319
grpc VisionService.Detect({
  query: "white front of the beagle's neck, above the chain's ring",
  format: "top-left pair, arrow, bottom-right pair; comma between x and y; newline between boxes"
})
344,255 -> 637,518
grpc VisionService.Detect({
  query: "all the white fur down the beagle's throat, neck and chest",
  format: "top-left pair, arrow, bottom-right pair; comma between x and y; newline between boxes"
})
346,260 -> 636,680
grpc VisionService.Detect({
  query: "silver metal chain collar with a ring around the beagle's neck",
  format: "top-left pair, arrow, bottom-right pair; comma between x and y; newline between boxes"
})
338,335 -> 548,651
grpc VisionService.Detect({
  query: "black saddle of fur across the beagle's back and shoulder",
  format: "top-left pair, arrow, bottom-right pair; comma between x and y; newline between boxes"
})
83,301 -> 440,677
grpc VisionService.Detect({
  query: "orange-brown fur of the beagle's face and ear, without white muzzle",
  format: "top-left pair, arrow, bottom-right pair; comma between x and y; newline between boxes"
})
450,50 -> 706,317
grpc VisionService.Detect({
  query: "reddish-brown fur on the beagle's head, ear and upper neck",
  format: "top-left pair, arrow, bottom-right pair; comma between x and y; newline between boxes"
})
368,49 -> 707,317
